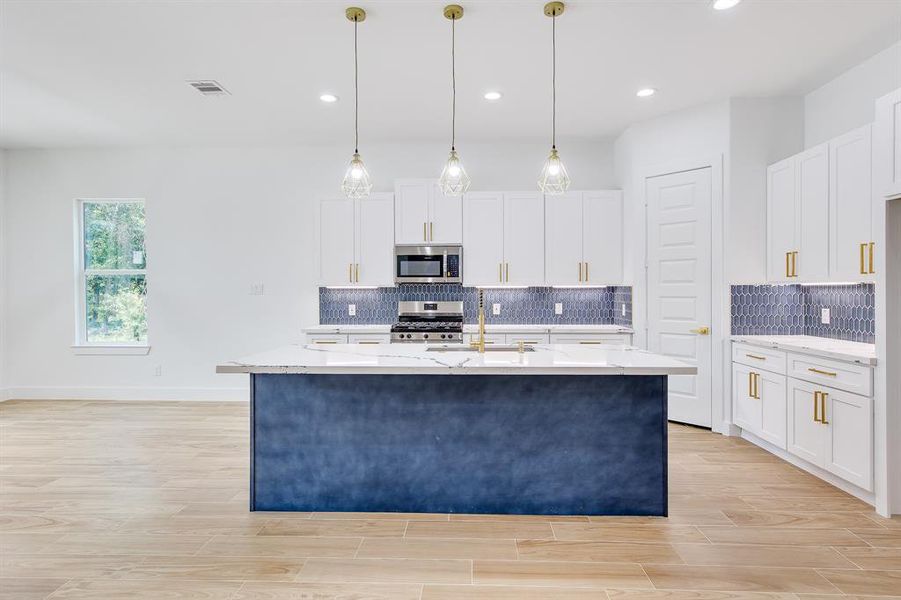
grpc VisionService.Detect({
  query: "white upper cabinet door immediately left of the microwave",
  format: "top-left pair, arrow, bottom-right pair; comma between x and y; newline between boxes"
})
354,194 -> 394,286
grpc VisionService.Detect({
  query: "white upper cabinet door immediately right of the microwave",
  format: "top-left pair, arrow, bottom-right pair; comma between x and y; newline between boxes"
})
463,192 -> 504,286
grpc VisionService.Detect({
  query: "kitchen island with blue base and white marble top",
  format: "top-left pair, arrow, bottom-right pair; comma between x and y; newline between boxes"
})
217,344 -> 696,515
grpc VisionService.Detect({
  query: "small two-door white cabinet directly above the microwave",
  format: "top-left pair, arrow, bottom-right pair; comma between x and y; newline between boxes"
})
394,179 -> 463,244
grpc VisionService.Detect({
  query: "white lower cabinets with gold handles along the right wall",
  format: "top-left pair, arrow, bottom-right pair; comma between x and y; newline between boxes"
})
732,344 -> 873,491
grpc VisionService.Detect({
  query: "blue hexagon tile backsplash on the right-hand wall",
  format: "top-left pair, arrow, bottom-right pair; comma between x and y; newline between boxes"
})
732,283 -> 876,344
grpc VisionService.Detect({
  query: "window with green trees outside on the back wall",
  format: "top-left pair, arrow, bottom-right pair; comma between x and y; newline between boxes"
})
76,200 -> 147,346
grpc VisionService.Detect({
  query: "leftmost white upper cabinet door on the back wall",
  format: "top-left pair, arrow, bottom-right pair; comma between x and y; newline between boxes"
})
319,198 -> 355,285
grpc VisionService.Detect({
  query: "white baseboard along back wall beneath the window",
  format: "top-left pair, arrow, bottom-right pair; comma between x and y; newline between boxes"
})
0,387 -> 250,402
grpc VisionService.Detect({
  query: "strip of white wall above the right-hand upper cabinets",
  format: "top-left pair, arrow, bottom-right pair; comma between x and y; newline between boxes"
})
804,42 -> 901,148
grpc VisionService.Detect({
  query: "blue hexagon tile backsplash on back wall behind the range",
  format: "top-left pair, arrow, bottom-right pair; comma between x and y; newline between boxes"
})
319,284 -> 632,327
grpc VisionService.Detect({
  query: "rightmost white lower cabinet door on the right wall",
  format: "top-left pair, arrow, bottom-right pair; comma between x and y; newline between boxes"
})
821,388 -> 873,490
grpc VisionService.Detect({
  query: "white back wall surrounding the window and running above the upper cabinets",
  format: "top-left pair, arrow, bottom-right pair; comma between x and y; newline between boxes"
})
4,141 -> 614,399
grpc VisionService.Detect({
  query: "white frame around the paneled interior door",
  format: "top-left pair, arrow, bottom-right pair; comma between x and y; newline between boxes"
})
631,153 -> 739,435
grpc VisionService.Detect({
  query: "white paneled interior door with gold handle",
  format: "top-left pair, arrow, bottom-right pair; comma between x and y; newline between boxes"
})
645,167 -> 712,427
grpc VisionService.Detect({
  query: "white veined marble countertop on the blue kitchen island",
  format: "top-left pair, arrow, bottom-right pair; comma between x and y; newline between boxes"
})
216,344 -> 697,375
